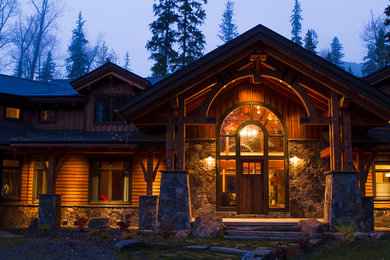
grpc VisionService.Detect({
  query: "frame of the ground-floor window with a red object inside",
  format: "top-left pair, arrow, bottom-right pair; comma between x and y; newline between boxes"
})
88,157 -> 133,205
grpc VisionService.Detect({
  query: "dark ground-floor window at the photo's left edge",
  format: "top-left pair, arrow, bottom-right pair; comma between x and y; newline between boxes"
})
1,159 -> 21,199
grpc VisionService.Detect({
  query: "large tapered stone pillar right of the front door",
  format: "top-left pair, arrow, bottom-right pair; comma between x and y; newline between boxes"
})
324,171 -> 364,230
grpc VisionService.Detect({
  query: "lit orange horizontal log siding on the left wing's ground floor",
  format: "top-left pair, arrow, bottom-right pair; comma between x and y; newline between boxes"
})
4,154 -> 165,206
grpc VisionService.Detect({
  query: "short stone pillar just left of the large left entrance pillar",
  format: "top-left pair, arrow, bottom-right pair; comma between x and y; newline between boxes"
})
138,196 -> 158,230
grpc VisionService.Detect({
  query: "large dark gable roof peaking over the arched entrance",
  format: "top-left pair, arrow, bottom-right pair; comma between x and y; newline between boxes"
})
120,25 -> 390,120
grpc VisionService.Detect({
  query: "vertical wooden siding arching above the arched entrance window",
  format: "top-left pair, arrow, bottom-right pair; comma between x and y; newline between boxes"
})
186,81 -> 322,140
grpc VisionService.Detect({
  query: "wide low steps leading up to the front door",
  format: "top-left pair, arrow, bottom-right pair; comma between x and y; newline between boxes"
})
223,221 -> 305,241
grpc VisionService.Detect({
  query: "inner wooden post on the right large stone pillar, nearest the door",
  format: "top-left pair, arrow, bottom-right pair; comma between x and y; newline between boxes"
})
329,91 -> 341,171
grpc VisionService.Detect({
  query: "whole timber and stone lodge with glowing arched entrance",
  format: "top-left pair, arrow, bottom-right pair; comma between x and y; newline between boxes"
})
0,25 -> 390,230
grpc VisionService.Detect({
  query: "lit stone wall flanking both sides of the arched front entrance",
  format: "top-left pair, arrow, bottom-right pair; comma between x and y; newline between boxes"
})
186,140 -> 329,218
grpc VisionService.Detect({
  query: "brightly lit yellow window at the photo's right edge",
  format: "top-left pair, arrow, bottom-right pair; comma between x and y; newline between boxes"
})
374,163 -> 390,199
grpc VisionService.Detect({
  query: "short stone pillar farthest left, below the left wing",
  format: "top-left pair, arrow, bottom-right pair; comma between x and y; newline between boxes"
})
38,194 -> 61,229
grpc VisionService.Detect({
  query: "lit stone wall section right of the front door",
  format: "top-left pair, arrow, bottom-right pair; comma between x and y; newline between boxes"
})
289,140 -> 329,218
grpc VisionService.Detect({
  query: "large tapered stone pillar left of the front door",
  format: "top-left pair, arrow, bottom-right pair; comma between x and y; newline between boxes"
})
157,170 -> 191,230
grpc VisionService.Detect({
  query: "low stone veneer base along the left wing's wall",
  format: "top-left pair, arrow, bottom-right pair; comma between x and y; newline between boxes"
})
1,205 -> 138,228
